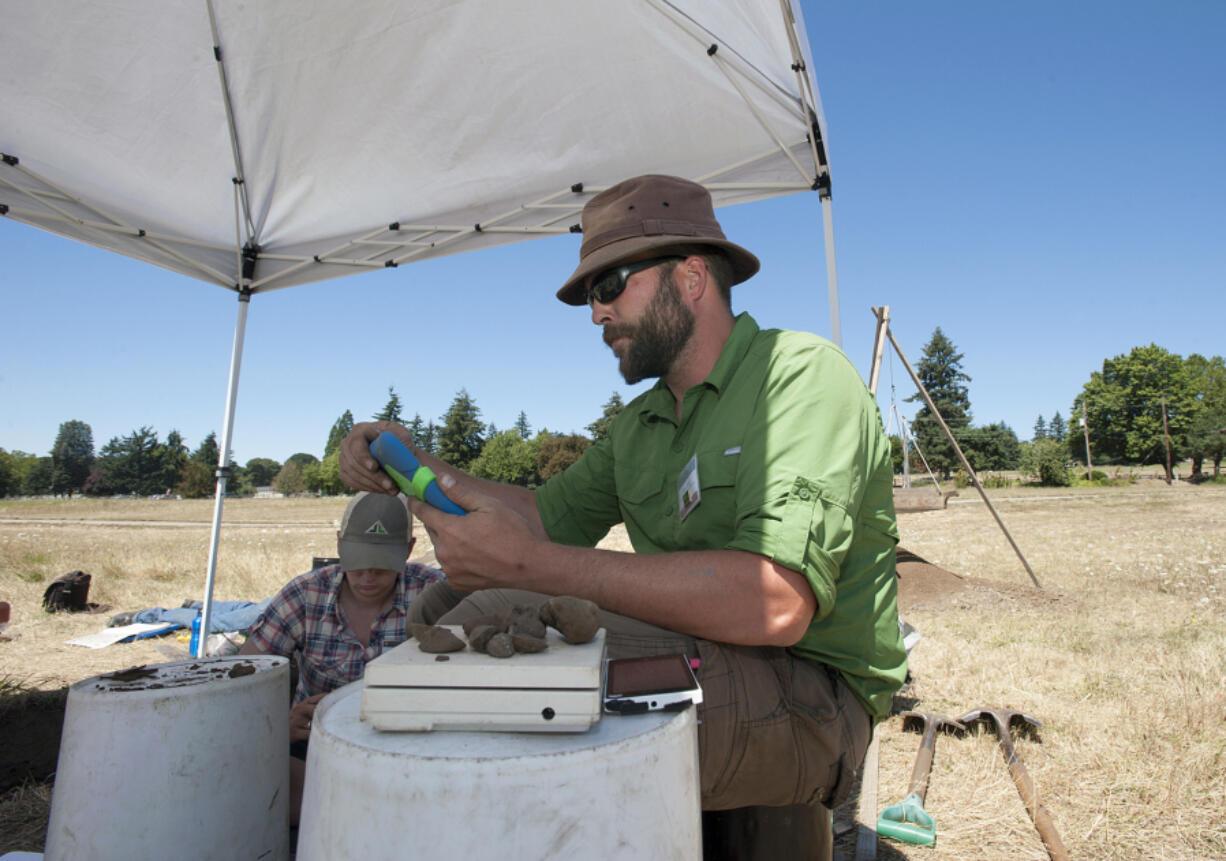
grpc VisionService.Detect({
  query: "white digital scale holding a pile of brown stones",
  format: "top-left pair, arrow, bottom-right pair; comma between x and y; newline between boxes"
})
362,626 -> 604,732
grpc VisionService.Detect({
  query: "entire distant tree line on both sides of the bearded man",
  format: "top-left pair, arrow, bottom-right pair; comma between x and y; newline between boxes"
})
7,326 -> 1226,497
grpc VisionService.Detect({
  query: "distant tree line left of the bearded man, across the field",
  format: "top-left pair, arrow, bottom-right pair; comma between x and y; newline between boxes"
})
0,386 -> 624,498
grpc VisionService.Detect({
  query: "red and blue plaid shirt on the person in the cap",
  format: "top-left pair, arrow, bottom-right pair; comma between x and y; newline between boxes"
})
248,562 -> 444,703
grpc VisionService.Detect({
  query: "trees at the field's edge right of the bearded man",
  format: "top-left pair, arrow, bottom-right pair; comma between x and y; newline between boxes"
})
893,326 -> 1226,484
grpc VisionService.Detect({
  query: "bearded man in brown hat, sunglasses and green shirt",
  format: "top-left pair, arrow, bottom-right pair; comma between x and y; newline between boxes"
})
341,175 -> 906,809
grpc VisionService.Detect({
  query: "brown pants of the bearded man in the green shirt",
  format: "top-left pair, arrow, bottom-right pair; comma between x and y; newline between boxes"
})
409,583 -> 873,809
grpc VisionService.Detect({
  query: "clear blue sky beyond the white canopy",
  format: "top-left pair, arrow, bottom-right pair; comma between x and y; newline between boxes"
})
0,0 -> 1226,462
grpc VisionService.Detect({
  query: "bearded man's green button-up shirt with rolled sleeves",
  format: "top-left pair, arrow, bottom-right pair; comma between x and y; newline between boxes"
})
536,314 -> 906,719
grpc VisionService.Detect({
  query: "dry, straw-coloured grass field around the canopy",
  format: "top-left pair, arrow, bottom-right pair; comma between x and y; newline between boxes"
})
0,481 -> 1226,861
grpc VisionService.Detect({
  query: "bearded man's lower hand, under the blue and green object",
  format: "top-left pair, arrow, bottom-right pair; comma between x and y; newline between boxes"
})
408,472 -> 546,591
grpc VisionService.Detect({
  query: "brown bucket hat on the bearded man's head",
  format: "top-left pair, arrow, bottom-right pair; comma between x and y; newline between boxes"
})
558,174 -> 758,305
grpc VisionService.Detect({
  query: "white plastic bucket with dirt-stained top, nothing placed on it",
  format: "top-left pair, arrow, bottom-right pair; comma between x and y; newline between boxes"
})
45,656 -> 289,861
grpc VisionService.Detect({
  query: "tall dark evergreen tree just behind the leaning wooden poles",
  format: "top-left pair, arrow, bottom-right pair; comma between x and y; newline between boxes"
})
907,326 -> 971,478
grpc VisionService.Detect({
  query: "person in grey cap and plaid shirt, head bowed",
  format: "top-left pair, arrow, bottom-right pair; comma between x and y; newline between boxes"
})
239,493 -> 443,825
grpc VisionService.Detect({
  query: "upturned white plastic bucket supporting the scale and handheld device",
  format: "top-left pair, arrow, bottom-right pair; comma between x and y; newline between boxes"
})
298,682 -> 702,861
